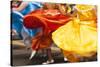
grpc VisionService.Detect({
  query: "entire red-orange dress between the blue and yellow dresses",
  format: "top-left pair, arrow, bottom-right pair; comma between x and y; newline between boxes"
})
24,9 -> 70,50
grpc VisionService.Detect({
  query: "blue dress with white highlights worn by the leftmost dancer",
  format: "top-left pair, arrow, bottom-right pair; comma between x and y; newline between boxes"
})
11,2 -> 42,39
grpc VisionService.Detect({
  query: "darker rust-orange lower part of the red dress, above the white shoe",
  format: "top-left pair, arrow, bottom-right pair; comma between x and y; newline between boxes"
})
32,32 -> 52,50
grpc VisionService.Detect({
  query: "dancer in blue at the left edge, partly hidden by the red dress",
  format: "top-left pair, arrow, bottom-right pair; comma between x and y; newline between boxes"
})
11,0 -> 42,46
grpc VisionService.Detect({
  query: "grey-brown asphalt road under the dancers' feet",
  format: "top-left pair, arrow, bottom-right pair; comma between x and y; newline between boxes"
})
11,40 -> 97,66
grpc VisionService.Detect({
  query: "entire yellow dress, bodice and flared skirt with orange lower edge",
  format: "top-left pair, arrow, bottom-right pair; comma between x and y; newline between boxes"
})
52,5 -> 97,62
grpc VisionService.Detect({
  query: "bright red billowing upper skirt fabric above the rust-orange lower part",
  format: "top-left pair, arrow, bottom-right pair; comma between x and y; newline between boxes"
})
24,9 -> 70,33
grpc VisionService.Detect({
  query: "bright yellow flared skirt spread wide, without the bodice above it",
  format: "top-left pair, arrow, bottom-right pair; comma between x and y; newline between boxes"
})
52,19 -> 97,57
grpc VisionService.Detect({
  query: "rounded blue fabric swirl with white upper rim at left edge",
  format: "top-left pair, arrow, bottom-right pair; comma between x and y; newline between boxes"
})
11,11 -> 23,35
